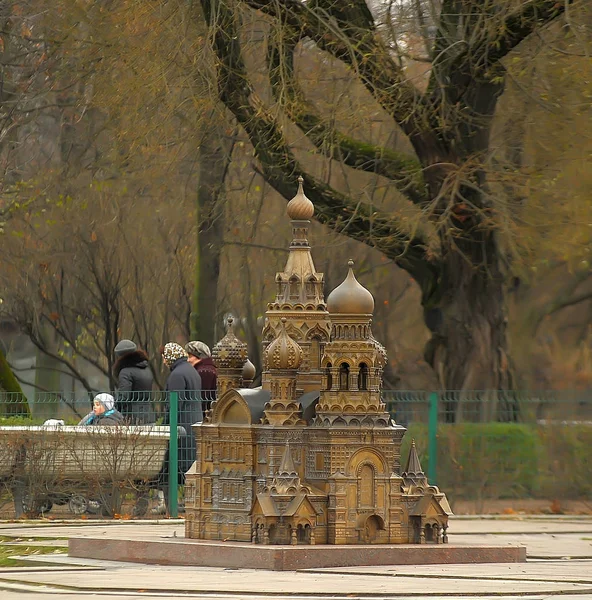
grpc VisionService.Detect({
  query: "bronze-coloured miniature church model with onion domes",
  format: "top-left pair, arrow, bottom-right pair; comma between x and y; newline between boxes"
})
185,179 -> 451,544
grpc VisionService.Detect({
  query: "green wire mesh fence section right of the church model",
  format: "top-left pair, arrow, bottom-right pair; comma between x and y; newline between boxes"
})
384,390 -> 592,512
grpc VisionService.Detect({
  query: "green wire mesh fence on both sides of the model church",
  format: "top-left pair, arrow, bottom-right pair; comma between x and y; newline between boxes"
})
0,390 -> 592,516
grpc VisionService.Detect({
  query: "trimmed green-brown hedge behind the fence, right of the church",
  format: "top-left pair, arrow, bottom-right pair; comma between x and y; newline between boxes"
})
401,423 -> 592,501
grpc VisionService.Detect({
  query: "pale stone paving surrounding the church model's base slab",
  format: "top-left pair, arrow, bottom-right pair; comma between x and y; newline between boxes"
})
0,516 -> 592,600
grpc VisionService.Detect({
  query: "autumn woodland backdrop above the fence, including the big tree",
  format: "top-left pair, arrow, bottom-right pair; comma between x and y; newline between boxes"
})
0,0 -> 592,404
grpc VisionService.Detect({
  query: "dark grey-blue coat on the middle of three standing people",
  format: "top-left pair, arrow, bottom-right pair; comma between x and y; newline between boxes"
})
165,358 -> 203,483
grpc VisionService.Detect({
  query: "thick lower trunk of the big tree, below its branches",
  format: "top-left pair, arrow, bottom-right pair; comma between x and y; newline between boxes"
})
424,244 -> 517,422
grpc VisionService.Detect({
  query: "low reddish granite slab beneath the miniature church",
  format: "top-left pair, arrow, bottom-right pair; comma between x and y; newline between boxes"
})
68,538 -> 526,571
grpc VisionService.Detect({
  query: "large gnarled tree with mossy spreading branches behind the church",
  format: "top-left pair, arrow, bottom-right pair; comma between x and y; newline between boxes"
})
196,0 -> 577,390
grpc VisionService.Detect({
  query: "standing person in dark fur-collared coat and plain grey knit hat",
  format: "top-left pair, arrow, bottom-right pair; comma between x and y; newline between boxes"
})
113,340 -> 154,425
